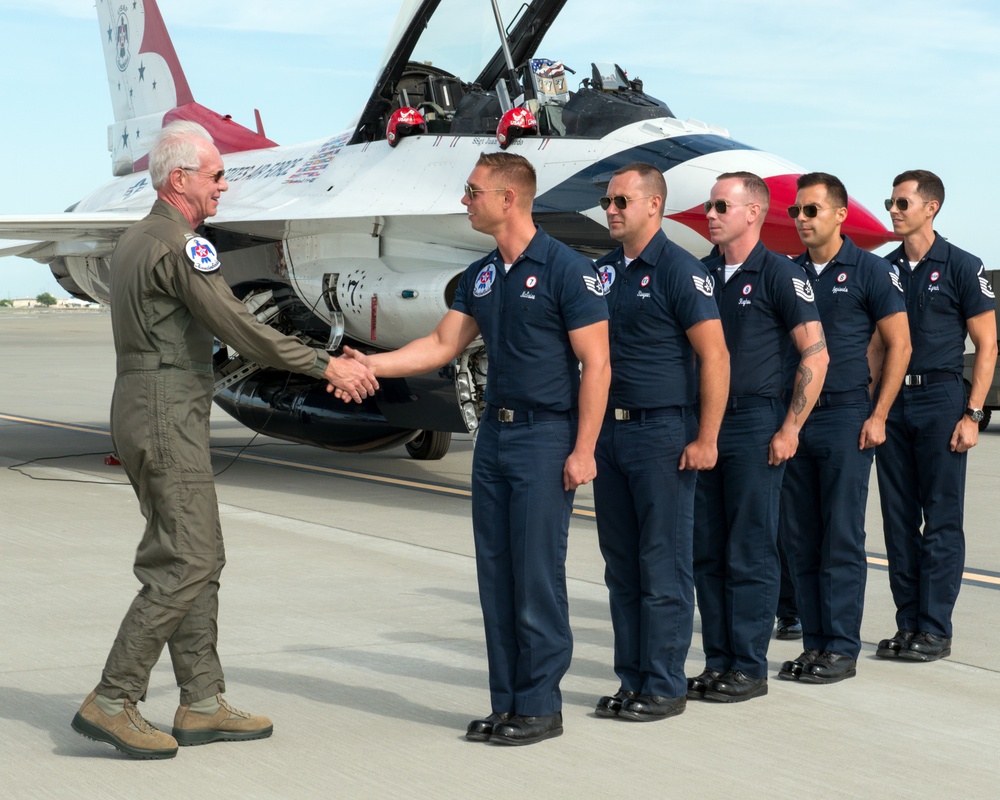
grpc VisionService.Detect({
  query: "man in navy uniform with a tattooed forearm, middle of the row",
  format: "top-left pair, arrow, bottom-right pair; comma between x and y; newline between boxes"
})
688,172 -> 829,702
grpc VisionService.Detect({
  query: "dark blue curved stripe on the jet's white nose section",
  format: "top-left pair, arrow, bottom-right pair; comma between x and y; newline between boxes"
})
533,133 -> 758,213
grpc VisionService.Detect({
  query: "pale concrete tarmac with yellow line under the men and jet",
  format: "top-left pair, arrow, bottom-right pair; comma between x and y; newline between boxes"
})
0,309 -> 1000,799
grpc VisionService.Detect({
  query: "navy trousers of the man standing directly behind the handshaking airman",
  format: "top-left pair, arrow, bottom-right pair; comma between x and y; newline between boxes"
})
594,409 -> 697,697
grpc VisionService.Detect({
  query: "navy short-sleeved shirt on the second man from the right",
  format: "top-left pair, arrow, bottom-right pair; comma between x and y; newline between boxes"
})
795,236 -> 906,392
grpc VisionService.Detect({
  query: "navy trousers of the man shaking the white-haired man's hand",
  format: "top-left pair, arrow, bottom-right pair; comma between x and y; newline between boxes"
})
472,418 -> 576,716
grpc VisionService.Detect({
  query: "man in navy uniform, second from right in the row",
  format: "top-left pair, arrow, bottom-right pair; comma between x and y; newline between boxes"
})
778,172 -> 910,683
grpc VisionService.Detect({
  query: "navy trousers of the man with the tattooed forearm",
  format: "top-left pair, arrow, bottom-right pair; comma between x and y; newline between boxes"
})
694,400 -> 785,678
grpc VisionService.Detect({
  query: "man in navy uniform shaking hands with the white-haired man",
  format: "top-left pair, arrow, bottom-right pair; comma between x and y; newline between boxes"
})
345,153 -> 610,745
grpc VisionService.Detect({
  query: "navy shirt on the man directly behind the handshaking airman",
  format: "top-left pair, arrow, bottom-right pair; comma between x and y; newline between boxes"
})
597,230 -> 719,408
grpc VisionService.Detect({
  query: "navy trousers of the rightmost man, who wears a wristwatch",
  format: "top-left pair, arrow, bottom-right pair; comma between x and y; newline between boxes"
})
875,375 -> 967,637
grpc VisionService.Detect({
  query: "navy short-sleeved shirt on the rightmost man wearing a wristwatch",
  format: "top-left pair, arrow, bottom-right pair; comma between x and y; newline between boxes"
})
885,232 -> 996,375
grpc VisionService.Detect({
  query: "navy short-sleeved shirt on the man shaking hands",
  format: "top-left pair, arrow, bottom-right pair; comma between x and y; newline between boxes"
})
451,228 -> 608,411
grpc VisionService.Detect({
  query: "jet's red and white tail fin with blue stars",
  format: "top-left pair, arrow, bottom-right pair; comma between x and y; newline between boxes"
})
97,0 -> 277,175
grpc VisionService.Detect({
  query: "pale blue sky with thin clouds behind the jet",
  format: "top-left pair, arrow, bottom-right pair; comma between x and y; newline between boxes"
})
0,0 -> 1000,297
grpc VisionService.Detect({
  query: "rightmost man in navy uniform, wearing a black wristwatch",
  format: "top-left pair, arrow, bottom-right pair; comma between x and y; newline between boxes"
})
875,170 -> 997,661
